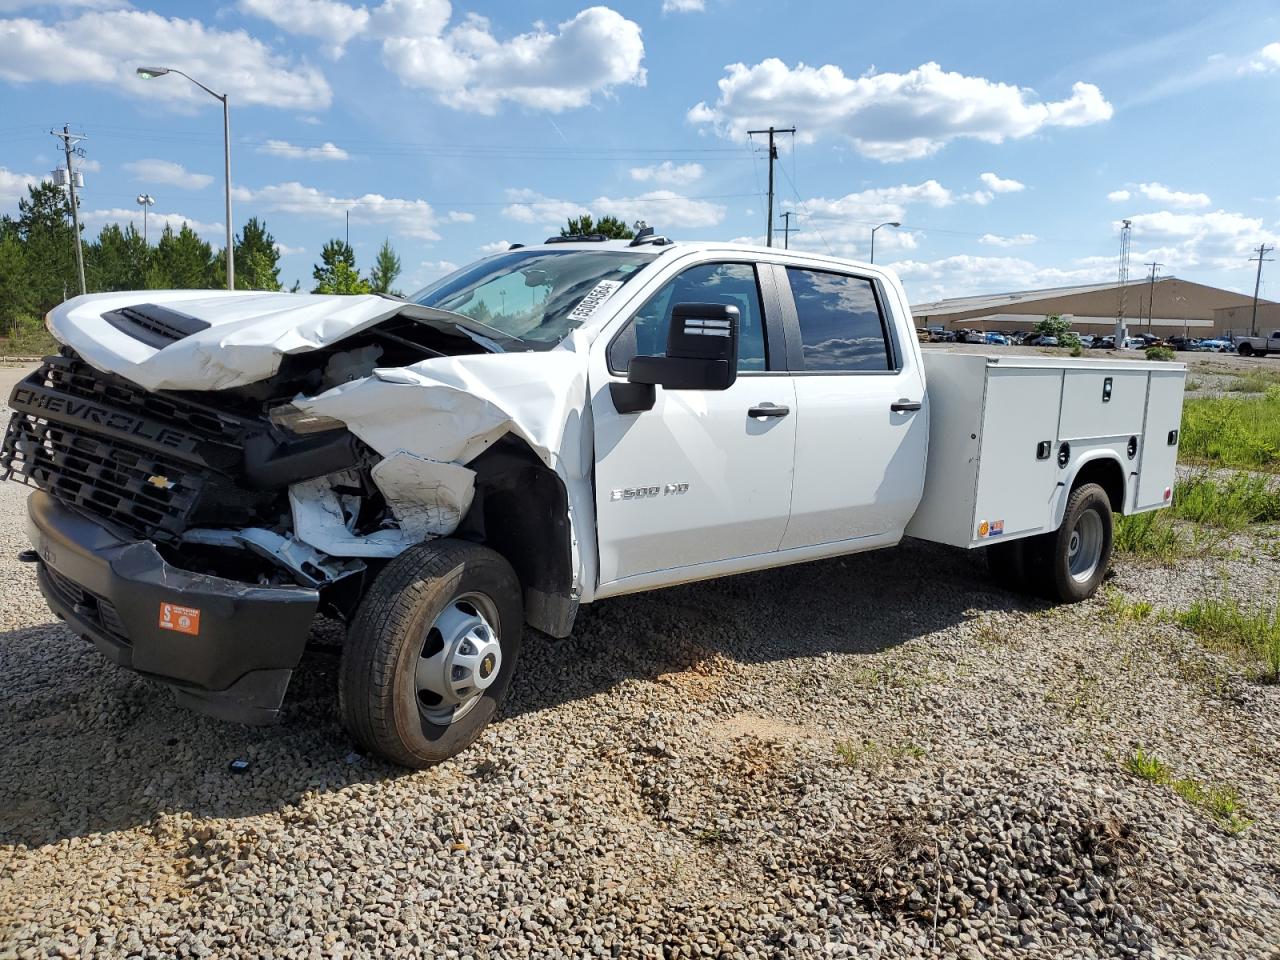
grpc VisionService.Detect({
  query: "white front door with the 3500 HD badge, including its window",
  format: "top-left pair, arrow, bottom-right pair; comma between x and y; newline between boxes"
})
591,261 -> 797,593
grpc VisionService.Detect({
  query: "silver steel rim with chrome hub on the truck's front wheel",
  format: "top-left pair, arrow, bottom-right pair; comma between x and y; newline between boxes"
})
410,594 -> 502,726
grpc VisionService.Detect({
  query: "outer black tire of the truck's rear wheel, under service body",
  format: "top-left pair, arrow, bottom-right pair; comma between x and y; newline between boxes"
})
1024,484 -> 1114,603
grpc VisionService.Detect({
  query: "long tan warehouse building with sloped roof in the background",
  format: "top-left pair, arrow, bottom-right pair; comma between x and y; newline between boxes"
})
911,276 -> 1280,337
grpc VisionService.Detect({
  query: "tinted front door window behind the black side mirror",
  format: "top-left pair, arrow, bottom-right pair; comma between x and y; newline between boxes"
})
609,264 -> 765,374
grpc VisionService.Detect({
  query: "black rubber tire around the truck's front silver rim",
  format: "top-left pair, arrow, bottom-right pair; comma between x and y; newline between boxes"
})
338,539 -> 524,768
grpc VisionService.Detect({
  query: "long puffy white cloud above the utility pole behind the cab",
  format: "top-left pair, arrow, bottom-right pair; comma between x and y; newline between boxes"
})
687,58 -> 1112,161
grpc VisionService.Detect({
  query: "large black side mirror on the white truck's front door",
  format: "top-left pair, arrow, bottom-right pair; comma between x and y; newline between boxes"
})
627,303 -> 739,390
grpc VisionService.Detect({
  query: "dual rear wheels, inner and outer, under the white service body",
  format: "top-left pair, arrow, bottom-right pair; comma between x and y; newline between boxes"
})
987,484 -> 1114,603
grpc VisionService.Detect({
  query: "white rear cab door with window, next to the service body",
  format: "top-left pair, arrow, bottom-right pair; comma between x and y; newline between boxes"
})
774,265 -> 928,549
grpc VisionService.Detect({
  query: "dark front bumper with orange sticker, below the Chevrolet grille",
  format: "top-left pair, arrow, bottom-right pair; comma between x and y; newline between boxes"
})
27,492 -> 320,723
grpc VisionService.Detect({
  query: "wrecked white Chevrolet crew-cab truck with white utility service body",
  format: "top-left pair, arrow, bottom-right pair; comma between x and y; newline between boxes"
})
0,233 -> 1185,767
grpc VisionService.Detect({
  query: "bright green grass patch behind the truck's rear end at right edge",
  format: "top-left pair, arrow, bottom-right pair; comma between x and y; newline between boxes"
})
1179,387 -> 1280,470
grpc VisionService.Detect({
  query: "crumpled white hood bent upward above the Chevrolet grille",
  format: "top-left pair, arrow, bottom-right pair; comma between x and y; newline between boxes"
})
49,291 -> 481,390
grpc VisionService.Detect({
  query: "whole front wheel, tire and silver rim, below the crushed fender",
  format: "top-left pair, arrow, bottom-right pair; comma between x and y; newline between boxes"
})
338,540 -> 524,768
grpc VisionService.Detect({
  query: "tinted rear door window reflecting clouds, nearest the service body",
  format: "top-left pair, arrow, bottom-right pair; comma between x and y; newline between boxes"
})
787,266 -> 892,370
